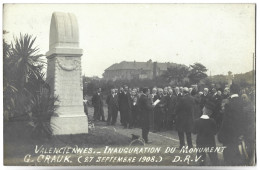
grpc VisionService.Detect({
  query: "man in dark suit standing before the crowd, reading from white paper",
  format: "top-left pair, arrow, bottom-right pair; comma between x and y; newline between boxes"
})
138,88 -> 153,143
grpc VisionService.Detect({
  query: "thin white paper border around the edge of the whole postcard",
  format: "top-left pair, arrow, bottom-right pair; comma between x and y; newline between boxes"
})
0,0 -> 260,170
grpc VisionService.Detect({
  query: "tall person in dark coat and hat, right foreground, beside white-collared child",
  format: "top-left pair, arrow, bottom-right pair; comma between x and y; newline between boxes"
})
218,84 -> 247,166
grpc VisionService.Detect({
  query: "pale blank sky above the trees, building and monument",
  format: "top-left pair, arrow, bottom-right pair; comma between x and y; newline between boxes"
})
3,4 -> 255,77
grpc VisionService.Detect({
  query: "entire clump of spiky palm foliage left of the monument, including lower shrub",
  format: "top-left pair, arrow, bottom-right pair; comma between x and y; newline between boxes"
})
3,34 -> 58,138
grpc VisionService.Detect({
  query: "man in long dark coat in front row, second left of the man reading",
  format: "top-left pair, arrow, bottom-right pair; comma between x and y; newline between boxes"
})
120,86 -> 132,128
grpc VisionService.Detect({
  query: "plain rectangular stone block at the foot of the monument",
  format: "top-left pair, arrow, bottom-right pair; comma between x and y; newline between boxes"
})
51,115 -> 88,135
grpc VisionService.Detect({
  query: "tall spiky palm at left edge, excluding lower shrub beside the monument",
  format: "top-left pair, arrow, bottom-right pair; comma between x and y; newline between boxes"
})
3,34 -> 44,120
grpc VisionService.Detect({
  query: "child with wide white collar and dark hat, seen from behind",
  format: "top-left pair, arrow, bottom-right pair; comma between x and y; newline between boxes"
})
192,101 -> 218,166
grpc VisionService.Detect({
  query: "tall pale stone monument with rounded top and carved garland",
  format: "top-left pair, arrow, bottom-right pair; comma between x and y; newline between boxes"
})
46,12 -> 88,135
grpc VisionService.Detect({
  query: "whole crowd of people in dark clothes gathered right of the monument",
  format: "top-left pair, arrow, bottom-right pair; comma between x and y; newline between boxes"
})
84,84 -> 255,165
